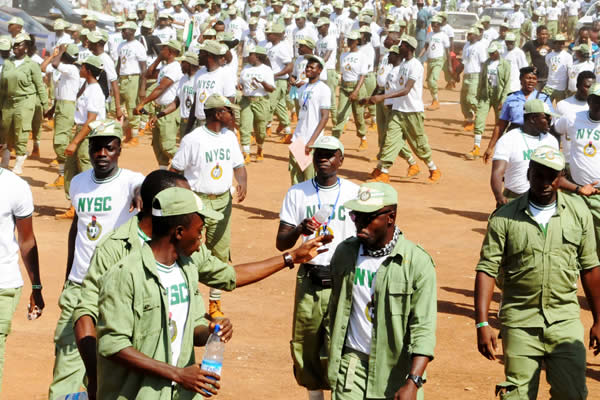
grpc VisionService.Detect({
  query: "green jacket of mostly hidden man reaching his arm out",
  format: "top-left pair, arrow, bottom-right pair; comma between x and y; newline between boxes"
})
73,216 -> 236,322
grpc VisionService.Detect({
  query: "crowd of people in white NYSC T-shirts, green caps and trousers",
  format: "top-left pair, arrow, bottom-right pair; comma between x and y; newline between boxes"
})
0,0 -> 600,400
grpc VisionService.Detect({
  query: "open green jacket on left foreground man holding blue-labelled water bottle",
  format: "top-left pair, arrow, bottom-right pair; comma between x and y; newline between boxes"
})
97,246 -> 207,400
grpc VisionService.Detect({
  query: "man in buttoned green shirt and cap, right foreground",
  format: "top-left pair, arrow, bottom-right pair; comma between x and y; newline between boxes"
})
475,146 -> 600,399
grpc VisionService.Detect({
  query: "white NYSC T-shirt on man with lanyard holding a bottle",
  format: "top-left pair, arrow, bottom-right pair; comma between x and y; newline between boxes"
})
279,178 -> 358,265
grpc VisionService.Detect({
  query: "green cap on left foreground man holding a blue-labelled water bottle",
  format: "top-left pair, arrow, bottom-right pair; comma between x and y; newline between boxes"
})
152,187 -> 223,221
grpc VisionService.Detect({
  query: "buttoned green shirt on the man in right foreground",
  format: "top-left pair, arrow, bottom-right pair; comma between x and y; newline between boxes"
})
476,192 -> 600,328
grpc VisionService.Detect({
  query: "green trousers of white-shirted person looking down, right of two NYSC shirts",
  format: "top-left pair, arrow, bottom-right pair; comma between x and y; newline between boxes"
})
240,96 -> 271,147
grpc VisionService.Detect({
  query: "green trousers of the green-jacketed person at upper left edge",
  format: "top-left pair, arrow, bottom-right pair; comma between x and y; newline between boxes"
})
0,95 -> 36,156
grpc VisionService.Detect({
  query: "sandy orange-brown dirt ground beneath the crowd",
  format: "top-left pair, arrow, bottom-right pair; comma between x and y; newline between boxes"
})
1,81 -> 600,400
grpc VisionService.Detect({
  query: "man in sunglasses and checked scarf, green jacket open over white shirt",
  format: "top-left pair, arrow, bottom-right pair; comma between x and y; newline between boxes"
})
328,182 -> 437,400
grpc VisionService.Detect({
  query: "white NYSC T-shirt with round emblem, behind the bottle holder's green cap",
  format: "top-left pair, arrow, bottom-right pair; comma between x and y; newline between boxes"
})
171,126 -> 244,194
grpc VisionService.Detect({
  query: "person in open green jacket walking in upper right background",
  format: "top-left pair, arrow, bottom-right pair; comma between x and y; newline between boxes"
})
465,43 -> 510,160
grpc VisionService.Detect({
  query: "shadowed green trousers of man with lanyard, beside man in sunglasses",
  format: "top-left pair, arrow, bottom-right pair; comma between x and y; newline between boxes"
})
290,265 -> 331,390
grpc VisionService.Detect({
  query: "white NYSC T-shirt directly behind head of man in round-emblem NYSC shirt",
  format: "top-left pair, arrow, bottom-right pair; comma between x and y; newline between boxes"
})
194,67 -> 236,120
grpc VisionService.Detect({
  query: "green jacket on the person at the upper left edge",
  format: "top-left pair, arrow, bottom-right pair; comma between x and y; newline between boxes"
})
0,56 -> 48,110
